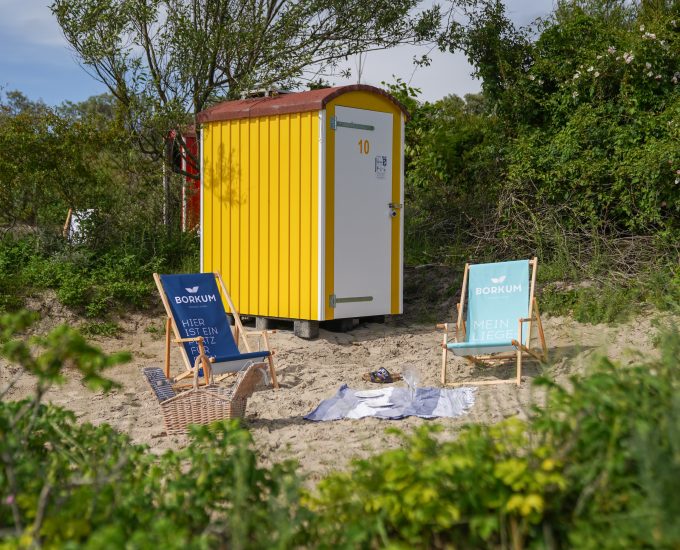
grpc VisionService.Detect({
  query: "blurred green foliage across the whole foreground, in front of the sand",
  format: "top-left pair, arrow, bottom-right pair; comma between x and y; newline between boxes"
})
0,314 -> 680,549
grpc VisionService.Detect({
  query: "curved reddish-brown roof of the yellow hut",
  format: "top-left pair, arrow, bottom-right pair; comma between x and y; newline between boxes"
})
196,84 -> 408,123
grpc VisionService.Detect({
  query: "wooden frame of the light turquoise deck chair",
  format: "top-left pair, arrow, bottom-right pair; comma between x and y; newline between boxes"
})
437,257 -> 548,386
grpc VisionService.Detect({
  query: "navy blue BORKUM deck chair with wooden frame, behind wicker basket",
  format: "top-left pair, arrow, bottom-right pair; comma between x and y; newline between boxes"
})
154,273 -> 279,388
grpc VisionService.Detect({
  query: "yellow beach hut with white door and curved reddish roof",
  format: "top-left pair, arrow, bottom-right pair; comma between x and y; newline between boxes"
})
198,84 -> 407,337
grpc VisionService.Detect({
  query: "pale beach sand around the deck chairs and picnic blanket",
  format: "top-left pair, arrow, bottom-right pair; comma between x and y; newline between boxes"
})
0,288 -> 672,481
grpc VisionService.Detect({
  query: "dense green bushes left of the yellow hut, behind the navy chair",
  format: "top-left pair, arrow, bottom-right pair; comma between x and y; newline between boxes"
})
0,92 -> 198,317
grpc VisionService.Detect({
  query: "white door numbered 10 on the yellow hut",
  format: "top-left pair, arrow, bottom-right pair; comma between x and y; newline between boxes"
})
331,107 -> 394,319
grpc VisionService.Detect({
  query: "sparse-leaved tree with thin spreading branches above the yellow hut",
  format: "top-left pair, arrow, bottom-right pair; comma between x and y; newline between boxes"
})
51,0 -> 439,175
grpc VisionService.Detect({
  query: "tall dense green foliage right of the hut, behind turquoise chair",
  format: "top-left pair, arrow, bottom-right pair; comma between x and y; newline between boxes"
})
391,0 -> 680,321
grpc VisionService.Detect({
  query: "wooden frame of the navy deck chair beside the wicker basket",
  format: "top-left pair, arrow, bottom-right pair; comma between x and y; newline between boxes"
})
153,271 -> 279,389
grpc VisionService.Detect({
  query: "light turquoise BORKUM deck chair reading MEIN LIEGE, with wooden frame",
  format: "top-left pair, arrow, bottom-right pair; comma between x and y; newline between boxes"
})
437,258 -> 548,386
